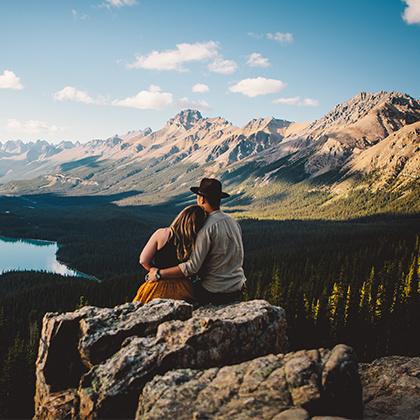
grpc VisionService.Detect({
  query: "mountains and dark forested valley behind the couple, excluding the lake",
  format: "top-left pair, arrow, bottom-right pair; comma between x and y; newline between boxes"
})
0,92 -> 420,417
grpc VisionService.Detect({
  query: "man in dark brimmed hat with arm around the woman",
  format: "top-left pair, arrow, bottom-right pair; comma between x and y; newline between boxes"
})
148,178 -> 246,304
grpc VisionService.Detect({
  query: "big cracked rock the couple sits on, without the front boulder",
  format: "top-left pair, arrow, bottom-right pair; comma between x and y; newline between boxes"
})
35,300 -> 287,419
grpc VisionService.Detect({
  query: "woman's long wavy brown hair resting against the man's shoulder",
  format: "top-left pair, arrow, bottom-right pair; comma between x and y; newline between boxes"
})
170,205 -> 206,262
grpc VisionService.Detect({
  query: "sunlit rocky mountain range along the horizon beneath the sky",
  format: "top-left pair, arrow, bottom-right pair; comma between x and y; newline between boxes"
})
0,91 -> 420,218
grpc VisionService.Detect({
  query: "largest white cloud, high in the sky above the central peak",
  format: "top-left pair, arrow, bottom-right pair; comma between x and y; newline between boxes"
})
128,41 -> 219,71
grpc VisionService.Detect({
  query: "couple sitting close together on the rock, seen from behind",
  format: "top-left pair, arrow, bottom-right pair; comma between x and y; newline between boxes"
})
134,178 -> 246,304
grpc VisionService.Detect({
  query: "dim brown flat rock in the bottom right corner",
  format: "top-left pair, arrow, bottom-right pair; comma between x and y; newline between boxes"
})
360,356 -> 420,420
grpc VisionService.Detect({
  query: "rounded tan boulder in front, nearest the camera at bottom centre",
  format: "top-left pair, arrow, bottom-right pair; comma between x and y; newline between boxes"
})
136,345 -> 362,420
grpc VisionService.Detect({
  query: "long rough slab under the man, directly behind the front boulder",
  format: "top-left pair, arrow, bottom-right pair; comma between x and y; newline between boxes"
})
79,300 -> 287,418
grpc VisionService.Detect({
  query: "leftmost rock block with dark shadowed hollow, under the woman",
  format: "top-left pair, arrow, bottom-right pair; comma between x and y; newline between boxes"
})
35,300 -> 192,419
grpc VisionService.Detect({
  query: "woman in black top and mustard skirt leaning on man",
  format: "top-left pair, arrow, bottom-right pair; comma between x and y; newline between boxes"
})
133,205 -> 206,303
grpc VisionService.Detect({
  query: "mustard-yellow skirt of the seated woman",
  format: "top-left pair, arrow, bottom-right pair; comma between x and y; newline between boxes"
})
133,279 -> 193,303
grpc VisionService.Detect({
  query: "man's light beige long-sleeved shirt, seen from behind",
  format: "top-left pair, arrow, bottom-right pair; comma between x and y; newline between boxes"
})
179,210 -> 246,293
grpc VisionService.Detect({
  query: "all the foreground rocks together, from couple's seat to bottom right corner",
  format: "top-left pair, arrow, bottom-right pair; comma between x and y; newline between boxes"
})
35,300 -> 420,420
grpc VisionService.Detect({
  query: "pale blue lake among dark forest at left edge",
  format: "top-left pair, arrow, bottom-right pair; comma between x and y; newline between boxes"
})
0,236 -> 93,279
